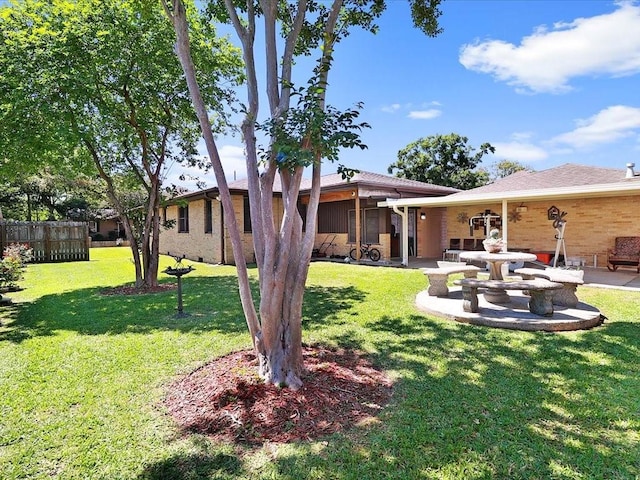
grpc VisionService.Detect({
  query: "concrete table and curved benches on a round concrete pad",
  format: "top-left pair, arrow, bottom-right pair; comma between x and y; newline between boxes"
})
416,252 -> 602,331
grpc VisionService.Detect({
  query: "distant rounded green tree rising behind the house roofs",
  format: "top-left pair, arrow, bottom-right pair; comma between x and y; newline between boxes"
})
388,133 -> 495,190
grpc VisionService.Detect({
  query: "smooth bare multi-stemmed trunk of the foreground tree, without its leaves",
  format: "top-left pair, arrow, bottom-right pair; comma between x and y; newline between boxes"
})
163,0 -> 342,389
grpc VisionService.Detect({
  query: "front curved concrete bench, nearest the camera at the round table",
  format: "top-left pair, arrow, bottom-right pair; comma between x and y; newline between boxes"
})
454,278 -> 562,317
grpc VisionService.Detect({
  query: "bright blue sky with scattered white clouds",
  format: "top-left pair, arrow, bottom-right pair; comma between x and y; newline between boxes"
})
179,0 -> 640,189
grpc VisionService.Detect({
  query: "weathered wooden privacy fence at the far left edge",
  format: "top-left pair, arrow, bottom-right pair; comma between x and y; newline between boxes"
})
0,221 -> 90,263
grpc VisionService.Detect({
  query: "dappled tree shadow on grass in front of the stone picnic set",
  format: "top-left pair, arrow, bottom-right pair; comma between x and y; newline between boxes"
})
268,315 -> 640,480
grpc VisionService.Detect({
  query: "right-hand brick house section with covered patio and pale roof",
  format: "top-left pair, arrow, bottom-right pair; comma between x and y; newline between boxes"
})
378,164 -> 640,267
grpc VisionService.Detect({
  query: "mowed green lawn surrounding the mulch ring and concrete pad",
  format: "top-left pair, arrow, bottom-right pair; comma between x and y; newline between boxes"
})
0,248 -> 640,480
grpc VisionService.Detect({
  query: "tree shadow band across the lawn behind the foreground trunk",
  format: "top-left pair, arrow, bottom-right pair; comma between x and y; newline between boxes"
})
0,276 -> 364,343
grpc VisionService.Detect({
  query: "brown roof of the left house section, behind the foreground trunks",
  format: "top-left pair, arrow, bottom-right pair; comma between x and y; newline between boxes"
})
168,171 -> 460,200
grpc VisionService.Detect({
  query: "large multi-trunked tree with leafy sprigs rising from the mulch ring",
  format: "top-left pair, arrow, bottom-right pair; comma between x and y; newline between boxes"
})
163,0 -> 440,388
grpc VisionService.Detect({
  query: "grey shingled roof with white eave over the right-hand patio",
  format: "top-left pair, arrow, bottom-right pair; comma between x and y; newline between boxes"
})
378,164 -> 640,206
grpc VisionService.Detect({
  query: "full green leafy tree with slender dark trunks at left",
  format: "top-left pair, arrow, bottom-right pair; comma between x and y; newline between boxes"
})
0,0 -> 241,287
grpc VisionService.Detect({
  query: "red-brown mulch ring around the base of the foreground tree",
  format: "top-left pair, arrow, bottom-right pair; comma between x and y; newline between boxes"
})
164,347 -> 392,444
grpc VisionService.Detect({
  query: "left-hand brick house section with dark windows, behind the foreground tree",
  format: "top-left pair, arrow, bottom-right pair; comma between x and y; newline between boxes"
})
160,172 -> 459,264
